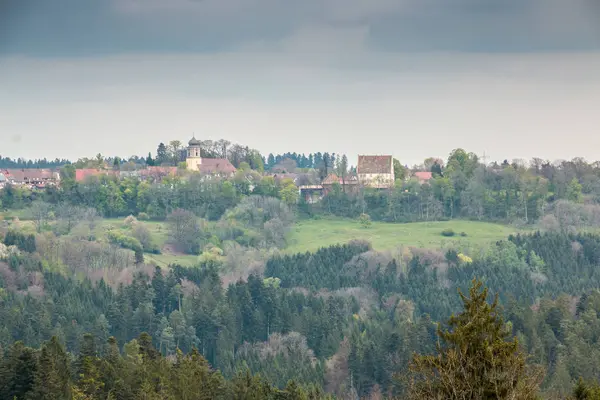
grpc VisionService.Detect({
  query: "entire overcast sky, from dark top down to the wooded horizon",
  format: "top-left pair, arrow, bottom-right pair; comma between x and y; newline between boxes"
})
0,0 -> 600,164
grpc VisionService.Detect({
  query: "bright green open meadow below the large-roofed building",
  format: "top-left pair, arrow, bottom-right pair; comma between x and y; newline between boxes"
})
286,218 -> 517,253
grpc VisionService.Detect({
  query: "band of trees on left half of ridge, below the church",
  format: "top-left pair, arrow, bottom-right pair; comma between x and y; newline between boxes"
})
0,171 -> 298,220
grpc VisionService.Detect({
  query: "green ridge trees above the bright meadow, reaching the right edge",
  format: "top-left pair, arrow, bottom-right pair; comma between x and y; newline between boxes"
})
312,149 -> 600,223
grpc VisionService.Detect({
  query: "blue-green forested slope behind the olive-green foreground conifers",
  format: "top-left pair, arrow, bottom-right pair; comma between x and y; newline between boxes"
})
0,233 -> 600,398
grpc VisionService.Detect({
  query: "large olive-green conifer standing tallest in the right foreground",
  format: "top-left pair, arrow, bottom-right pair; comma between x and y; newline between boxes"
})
409,280 -> 541,400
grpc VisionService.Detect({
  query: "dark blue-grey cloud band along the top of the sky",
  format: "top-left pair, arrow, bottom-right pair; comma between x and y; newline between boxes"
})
0,0 -> 600,55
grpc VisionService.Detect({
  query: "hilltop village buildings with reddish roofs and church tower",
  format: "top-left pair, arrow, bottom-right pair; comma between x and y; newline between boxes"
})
0,137 -> 432,203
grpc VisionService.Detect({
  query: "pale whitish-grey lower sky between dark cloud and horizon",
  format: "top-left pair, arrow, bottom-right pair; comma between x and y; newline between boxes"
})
0,51 -> 600,164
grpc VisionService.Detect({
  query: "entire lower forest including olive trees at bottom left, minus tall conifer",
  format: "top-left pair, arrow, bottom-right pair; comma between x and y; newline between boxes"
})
0,233 -> 600,399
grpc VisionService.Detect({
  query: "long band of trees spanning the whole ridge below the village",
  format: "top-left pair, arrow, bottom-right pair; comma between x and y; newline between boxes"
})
5,148 -> 600,227
